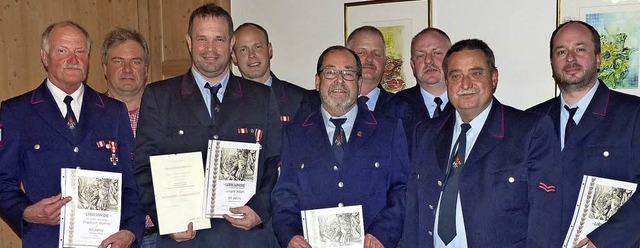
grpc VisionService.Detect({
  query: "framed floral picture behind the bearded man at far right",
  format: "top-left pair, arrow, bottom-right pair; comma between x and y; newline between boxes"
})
558,0 -> 640,95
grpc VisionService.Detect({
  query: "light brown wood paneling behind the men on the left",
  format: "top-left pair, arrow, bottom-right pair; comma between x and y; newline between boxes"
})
0,0 -> 231,248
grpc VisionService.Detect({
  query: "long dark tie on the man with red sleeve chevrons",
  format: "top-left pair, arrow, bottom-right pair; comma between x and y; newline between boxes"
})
438,123 -> 471,245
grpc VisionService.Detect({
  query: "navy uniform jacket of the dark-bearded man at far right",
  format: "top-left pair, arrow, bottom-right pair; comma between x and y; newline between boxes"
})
529,81 -> 640,247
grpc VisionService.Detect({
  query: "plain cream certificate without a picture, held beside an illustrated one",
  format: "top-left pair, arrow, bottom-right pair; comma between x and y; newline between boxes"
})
149,152 -> 211,235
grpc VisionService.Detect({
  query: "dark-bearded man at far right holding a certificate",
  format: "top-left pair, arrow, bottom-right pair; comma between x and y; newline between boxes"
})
528,21 -> 640,247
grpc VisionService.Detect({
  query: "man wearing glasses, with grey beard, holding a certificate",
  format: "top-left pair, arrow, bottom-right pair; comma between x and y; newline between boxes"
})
272,46 -> 409,247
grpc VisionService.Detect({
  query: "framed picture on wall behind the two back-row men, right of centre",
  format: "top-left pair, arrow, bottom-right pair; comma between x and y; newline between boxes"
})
344,0 -> 431,93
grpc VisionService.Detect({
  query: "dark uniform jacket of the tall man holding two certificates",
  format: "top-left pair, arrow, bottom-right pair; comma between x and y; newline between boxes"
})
134,70 -> 280,247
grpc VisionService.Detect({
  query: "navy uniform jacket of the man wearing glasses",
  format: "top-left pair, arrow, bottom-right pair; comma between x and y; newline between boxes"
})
272,107 -> 408,247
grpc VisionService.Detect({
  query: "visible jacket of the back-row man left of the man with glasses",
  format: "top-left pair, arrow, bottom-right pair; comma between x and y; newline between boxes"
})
271,72 -> 307,124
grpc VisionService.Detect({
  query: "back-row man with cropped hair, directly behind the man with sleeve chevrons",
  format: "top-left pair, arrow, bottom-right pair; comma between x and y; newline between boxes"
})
397,28 -> 453,119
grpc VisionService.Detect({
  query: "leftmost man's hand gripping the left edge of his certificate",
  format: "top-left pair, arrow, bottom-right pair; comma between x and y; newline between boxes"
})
22,194 -> 71,225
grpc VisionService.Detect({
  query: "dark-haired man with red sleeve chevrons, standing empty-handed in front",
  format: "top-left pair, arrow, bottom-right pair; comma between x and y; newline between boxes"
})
402,39 -> 562,247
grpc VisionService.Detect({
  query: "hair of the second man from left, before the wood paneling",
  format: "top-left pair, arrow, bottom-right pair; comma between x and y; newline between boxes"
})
102,27 -> 150,66
